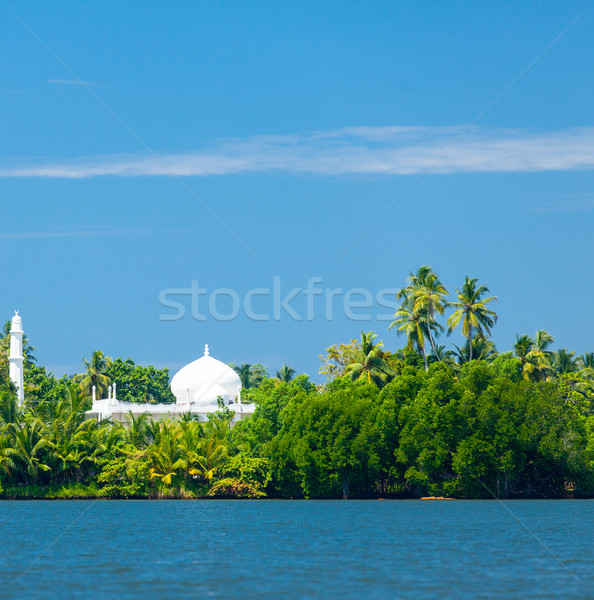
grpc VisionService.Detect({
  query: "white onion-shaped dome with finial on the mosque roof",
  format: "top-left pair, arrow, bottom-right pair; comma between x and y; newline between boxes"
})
171,344 -> 241,406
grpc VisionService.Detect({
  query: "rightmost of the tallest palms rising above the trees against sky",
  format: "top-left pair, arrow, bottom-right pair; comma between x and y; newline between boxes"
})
448,275 -> 497,360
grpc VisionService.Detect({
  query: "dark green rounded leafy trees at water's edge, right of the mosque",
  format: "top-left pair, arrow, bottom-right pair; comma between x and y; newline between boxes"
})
237,364 -> 594,498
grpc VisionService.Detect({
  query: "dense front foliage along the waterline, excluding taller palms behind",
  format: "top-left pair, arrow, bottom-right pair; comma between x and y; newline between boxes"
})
0,355 -> 594,498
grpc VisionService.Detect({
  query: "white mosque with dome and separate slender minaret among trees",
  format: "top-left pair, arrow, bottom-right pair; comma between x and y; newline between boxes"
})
9,312 -> 255,422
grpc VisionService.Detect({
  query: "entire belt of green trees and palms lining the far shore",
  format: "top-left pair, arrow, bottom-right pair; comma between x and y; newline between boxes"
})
0,266 -> 594,500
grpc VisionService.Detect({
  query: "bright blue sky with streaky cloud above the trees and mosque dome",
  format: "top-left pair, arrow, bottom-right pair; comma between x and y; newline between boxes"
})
0,2 -> 594,380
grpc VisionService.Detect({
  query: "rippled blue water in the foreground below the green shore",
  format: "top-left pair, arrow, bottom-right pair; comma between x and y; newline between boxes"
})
0,500 -> 594,600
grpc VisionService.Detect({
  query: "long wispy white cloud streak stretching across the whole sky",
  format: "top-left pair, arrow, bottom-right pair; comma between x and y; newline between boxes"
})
0,126 -> 594,178
